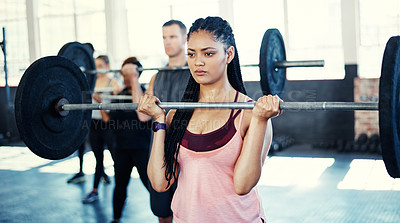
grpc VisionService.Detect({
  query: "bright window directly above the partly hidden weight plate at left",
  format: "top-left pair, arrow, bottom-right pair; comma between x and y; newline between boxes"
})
38,0 -> 107,56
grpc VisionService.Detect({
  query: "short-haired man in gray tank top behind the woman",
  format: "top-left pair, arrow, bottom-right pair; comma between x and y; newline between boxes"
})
126,20 -> 190,223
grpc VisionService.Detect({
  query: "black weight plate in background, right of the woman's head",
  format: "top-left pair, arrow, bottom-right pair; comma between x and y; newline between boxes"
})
259,29 -> 286,98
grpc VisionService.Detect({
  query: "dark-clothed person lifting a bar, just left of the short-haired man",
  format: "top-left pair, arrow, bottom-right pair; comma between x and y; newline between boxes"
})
110,57 -> 151,222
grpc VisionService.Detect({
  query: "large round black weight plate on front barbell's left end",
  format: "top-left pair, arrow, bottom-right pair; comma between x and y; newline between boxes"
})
15,56 -> 92,160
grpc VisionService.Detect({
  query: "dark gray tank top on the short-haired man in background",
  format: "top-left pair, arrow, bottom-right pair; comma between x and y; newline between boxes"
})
153,70 -> 191,102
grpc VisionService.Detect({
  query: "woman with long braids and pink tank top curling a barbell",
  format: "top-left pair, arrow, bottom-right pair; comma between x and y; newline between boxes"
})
138,17 -> 280,223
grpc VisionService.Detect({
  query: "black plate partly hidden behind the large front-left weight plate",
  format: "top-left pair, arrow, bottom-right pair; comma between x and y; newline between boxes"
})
57,42 -> 96,91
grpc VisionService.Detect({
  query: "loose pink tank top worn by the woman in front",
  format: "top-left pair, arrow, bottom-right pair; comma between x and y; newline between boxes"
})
171,95 -> 265,223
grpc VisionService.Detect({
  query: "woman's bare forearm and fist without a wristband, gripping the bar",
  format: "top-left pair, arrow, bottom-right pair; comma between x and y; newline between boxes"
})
233,96 -> 280,195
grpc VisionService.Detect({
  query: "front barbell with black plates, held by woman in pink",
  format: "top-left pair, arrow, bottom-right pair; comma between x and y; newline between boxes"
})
15,30 -> 400,178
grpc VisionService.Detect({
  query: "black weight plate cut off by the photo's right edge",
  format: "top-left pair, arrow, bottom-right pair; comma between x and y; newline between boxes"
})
379,36 -> 400,178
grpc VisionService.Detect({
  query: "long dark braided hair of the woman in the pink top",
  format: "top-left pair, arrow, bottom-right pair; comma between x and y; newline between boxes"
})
164,17 -> 246,187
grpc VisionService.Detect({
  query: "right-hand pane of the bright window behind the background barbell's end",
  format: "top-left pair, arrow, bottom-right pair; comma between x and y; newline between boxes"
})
285,0 -> 345,80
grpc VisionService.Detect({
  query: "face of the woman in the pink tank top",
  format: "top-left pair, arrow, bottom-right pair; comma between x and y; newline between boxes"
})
187,30 -> 234,85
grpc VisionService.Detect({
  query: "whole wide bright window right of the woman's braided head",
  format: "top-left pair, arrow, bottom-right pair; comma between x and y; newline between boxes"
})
234,0 -> 344,81
